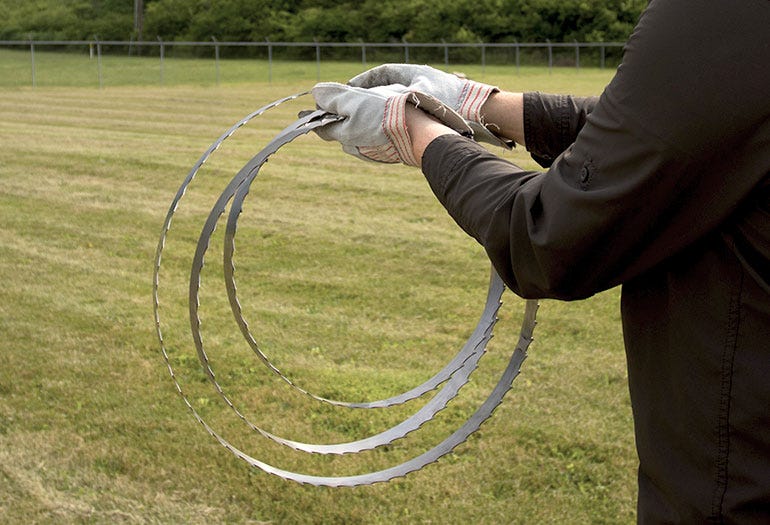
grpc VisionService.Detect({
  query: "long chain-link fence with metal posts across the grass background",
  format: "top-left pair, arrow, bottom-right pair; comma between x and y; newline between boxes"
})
0,38 -> 624,87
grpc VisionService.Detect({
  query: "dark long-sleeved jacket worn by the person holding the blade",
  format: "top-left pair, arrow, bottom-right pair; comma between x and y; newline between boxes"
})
422,0 -> 770,523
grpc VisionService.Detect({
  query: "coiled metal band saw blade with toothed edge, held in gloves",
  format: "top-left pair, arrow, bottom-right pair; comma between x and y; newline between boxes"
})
153,93 -> 538,487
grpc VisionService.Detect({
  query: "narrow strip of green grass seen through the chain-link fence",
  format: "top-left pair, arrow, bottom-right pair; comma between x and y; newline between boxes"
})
0,46 -> 612,94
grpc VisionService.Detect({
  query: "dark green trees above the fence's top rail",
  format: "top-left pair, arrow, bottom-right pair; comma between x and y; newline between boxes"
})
0,0 -> 647,43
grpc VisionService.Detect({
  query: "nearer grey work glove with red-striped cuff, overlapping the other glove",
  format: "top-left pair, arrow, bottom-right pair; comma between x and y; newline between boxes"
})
311,82 -> 473,166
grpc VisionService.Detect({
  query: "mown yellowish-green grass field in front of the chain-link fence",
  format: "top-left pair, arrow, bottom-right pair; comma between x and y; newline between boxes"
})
0,55 -> 636,524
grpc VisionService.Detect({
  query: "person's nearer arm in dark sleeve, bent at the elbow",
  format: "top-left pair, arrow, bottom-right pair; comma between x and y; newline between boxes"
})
410,0 -> 770,299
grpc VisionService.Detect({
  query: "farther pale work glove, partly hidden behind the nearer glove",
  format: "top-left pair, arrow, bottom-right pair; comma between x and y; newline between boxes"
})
348,64 -> 499,125
